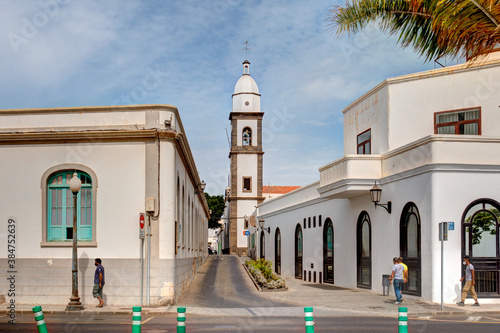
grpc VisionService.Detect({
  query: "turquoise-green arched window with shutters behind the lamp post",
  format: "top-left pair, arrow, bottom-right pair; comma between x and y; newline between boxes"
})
47,170 -> 92,242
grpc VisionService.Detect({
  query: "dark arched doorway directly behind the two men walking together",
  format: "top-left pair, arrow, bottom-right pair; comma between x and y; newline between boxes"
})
399,202 -> 422,296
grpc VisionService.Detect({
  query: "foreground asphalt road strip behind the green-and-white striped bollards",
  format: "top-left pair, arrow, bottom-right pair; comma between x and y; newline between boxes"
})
0,314 -> 500,333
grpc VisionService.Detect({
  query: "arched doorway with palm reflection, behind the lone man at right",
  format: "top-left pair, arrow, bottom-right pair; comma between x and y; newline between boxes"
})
462,199 -> 500,297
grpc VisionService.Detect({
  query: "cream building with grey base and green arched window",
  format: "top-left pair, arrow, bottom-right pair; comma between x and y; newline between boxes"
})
0,105 -> 208,305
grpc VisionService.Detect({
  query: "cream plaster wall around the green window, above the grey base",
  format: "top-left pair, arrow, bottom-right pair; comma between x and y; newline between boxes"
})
0,143 -> 145,259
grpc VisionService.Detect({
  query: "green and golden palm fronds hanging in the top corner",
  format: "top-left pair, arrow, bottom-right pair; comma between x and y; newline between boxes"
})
329,0 -> 500,61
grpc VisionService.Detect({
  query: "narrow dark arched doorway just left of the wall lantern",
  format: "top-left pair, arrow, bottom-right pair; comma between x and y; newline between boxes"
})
356,212 -> 372,289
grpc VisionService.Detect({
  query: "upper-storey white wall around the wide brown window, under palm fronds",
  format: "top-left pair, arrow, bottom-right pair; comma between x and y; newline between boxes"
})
389,66 -> 500,149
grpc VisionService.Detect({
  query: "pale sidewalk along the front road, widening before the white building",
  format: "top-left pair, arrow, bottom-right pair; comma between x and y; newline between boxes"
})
0,257 -> 500,317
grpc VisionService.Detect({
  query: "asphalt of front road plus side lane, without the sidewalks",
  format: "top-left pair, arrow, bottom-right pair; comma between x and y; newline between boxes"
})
0,256 -> 500,333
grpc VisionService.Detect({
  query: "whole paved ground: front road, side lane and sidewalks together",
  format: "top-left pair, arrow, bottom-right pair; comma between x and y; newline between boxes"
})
0,256 -> 500,333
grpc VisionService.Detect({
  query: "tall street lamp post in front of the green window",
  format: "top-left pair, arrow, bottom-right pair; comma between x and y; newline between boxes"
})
66,172 -> 83,311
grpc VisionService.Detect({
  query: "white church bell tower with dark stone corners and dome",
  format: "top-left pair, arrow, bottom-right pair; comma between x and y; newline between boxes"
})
229,60 -> 264,254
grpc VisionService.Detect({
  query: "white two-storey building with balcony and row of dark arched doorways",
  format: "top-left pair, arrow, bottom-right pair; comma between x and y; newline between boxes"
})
250,52 -> 500,303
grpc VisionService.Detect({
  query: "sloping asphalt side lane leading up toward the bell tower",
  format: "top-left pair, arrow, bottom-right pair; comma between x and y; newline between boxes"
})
179,256 -> 296,308
